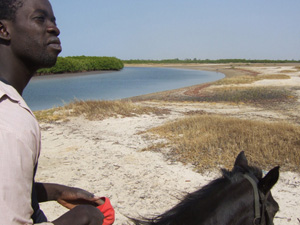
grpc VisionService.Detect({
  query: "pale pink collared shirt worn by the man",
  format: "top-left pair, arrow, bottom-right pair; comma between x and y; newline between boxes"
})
0,81 -> 52,225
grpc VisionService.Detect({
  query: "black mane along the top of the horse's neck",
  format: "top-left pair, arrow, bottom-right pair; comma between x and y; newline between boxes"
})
133,166 -> 262,225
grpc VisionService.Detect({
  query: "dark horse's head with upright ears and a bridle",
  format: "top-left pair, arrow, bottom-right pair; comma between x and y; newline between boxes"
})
232,152 -> 279,225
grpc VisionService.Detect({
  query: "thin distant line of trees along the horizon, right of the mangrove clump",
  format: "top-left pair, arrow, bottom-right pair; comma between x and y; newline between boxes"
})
123,58 -> 300,64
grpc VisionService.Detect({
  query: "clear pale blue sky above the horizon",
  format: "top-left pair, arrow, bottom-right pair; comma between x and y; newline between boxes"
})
50,0 -> 300,60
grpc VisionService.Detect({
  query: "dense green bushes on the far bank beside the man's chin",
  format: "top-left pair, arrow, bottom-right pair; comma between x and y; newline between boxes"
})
37,56 -> 124,75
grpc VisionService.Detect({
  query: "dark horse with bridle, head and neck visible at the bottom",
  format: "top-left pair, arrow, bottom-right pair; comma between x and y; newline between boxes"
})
132,152 -> 279,225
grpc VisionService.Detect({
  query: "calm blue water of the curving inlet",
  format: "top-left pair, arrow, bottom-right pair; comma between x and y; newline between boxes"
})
23,67 -> 224,110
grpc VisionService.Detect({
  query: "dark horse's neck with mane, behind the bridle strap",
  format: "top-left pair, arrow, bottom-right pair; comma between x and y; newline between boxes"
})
145,179 -> 254,225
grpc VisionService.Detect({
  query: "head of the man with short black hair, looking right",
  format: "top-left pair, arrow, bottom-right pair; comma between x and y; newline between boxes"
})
0,0 -> 61,70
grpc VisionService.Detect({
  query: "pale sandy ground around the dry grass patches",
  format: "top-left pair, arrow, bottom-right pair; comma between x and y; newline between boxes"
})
36,64 -> 300,225
